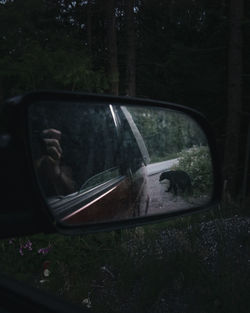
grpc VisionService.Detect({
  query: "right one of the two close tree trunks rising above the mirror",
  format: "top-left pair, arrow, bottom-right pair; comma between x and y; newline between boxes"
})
126,0 -> 136,96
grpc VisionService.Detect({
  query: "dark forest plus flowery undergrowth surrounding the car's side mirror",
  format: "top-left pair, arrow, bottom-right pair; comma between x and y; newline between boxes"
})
0,0 -> 250,313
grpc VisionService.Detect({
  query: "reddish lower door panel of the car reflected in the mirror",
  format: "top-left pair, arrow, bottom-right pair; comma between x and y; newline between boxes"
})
62,166 -> 149,225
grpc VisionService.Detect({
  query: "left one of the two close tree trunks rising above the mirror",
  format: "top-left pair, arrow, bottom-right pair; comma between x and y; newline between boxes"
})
106,0 -> 119,95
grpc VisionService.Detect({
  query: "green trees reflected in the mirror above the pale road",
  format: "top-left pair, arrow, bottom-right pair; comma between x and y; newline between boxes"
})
129,107 -> 206,163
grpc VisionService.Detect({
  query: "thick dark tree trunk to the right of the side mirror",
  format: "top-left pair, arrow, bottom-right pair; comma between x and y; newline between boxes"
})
223,0 -> 243,197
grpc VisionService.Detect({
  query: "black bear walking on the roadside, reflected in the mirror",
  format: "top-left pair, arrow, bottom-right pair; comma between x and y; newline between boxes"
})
159,171 -> 192,196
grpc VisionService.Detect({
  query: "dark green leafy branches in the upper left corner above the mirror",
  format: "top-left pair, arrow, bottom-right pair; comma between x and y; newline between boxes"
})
0,0 -> 108,97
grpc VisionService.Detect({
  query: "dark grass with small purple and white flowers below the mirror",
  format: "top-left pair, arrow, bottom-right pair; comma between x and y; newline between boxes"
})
0,202 -> 250,313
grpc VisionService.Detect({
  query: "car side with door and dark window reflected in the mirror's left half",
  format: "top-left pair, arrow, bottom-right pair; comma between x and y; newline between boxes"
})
30,103 -> 135,224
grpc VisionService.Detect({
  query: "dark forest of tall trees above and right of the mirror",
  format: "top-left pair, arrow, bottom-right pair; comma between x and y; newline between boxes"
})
0,0 -> 250,205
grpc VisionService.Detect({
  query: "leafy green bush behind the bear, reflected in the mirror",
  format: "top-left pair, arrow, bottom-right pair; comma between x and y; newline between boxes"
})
172,146 -> 213,195
